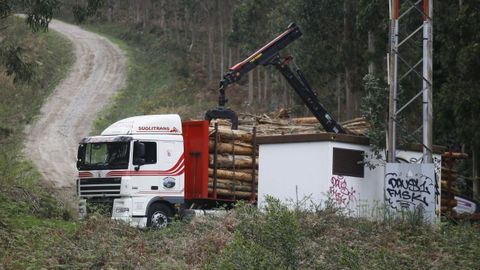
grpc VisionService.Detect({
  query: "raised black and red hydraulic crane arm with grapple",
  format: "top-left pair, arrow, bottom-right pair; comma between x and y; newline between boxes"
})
205,24 -> 346,133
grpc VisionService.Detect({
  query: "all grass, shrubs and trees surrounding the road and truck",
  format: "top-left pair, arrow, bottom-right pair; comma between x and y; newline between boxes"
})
0,0 -> 480,269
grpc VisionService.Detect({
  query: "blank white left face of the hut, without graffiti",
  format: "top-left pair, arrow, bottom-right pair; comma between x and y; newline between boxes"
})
258,142 -> 332,209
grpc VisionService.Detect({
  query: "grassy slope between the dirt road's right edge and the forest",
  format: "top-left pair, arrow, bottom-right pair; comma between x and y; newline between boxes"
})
85,23 -> 217,133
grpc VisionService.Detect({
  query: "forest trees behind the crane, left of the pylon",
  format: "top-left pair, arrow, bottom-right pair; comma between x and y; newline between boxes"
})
57,0 -> 388,120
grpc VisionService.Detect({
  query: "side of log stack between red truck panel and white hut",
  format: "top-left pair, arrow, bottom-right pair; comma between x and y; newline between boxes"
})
208,121 -> 258,200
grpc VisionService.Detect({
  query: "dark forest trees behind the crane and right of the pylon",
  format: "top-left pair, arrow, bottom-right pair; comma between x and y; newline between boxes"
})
53,0 -> 479,131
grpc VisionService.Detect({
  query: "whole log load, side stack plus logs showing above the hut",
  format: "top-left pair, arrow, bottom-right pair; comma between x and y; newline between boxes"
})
208,110 -> 369,200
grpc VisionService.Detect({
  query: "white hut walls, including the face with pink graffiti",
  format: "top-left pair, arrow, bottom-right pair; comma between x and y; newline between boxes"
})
258,141 -> 440,216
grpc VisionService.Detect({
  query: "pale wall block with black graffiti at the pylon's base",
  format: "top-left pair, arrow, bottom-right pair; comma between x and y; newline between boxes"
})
385,164 -> 439,212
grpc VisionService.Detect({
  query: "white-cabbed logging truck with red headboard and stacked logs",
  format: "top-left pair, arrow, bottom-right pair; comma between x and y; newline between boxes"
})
77,115 -> 257,227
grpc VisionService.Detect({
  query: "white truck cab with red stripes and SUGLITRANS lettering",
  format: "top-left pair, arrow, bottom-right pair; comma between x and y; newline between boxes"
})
77,115 -> 185,227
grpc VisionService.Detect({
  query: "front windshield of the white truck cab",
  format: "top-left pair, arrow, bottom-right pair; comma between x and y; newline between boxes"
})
77,142 -> 130,170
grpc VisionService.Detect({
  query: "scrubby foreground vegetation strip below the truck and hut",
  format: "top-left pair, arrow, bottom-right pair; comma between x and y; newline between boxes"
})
1,197 -> 480,269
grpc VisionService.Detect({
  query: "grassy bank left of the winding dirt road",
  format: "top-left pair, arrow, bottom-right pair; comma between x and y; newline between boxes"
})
0,18 -> 73,216
